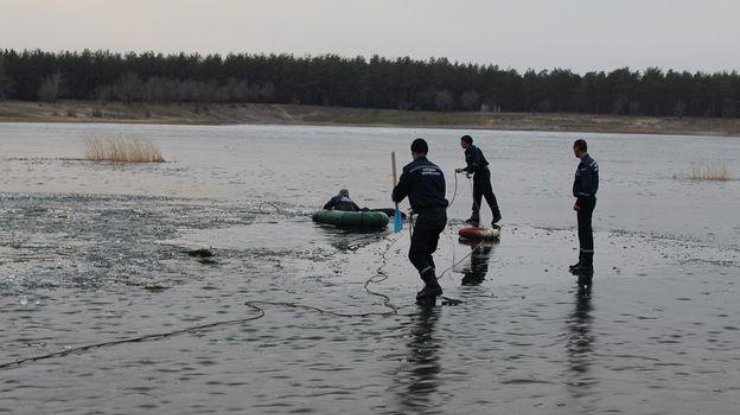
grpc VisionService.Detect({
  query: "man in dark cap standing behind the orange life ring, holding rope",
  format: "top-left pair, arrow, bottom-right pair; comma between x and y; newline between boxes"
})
455,135 -> 501,227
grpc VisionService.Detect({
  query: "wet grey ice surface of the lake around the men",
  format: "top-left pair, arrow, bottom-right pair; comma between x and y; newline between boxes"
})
0,124 -> 740,414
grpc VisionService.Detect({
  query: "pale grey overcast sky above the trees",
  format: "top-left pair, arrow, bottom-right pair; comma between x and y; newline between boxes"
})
0,0 -> 740,72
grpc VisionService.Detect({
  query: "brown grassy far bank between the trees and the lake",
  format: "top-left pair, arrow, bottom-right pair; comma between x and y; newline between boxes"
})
0,101 -> 740,137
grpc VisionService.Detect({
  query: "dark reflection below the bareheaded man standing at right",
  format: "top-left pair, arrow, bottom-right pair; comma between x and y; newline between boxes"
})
567,273 -> 595,404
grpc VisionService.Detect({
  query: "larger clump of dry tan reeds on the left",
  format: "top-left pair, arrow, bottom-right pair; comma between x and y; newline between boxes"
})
85,135 -> 165,163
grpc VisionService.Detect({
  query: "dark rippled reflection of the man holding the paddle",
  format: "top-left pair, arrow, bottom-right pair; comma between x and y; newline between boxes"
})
398,307 -> 442,413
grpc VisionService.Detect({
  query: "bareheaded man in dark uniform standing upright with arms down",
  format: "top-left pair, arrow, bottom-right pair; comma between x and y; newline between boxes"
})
570,140 -> 599,274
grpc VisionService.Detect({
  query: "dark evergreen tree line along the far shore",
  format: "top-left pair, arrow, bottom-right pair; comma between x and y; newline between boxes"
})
0,49 -> 740,117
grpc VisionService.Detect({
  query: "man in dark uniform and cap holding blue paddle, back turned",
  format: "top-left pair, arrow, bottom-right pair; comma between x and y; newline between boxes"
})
392,138 -> 448,304
